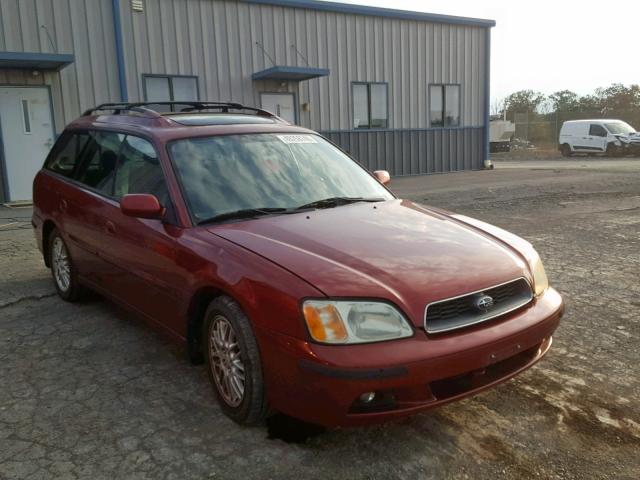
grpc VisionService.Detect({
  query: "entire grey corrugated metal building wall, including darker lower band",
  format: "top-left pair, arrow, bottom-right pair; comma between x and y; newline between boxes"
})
0,0 -> 487,180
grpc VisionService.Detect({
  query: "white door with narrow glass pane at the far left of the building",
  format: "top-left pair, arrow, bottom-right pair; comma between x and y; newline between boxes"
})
0,87 -> 53,201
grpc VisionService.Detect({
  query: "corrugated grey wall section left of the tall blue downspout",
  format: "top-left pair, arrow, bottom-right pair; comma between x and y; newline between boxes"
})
0,0 -> 120,131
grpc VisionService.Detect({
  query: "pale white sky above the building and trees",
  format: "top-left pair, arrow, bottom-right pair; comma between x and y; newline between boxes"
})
338,0 -> 640,102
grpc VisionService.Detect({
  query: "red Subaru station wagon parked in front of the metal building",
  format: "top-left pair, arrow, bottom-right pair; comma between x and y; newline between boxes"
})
33,102 -> 563,426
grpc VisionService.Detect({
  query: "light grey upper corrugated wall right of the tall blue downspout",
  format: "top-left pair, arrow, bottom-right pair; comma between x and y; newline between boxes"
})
116,0 -> 485,130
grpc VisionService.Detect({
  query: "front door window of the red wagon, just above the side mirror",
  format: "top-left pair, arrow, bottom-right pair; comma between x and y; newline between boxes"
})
114,135 -> 169,205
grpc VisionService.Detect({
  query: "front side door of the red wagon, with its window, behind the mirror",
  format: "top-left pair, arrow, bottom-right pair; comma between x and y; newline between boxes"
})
100,135 -> 185,335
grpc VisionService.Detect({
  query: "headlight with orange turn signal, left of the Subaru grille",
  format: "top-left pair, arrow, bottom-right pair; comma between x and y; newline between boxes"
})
302,300 -> 413,344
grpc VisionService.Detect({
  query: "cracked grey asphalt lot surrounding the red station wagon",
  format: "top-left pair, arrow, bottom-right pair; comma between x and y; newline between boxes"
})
0,156 -> 640,480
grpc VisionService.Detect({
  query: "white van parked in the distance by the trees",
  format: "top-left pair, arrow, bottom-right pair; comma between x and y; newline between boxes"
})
558,119 -> 640,157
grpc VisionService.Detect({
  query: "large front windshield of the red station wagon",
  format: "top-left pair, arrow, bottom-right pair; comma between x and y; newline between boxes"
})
169,133 -> 393,223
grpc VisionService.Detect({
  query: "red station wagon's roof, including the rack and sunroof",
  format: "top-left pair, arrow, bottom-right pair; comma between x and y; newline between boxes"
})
67,102 -> 315,141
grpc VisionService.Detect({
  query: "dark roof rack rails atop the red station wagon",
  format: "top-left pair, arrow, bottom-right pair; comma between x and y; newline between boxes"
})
82,102 -> 281,120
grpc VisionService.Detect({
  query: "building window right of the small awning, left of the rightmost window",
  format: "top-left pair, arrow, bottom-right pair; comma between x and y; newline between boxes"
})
351,82 -> 389,128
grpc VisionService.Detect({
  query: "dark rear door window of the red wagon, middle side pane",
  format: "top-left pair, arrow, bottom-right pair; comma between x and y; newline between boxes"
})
76,131 -> 124,196
